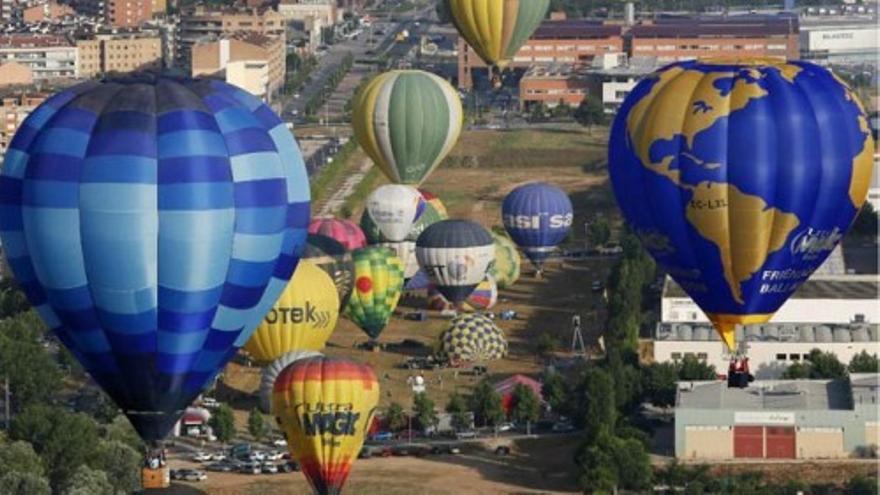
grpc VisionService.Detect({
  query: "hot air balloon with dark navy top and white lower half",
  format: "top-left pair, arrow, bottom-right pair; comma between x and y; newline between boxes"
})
416,220 -> 495,305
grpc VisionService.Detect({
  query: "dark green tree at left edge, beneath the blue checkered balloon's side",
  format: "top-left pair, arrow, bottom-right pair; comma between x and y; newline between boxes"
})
0,311 -> 61,412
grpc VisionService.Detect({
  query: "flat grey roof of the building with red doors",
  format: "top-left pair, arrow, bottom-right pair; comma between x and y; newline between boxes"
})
675,375 -> 852,411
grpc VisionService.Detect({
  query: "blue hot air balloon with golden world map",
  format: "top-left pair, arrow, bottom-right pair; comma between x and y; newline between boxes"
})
609,59 -> 874,350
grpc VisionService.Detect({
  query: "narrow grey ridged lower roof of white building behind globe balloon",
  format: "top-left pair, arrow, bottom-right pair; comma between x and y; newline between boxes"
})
654,323 -> 880,344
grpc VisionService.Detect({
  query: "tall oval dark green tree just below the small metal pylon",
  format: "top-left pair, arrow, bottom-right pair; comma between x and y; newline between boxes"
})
572,366 -> 617,441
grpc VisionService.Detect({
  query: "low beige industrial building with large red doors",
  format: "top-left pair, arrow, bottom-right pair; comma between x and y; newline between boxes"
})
675,373 -> 880,461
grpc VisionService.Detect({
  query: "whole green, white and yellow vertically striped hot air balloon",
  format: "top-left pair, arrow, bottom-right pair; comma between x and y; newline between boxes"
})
352,70 -> 464,185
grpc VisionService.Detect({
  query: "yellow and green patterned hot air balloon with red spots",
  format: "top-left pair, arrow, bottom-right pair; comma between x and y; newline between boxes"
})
345,246 -> 403,341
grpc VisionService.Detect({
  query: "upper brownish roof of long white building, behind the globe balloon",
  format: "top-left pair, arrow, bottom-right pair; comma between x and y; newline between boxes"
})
663,275 -> 880,299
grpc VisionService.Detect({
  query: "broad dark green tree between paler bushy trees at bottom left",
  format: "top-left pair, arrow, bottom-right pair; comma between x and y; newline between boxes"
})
9,404 -> 99,492
